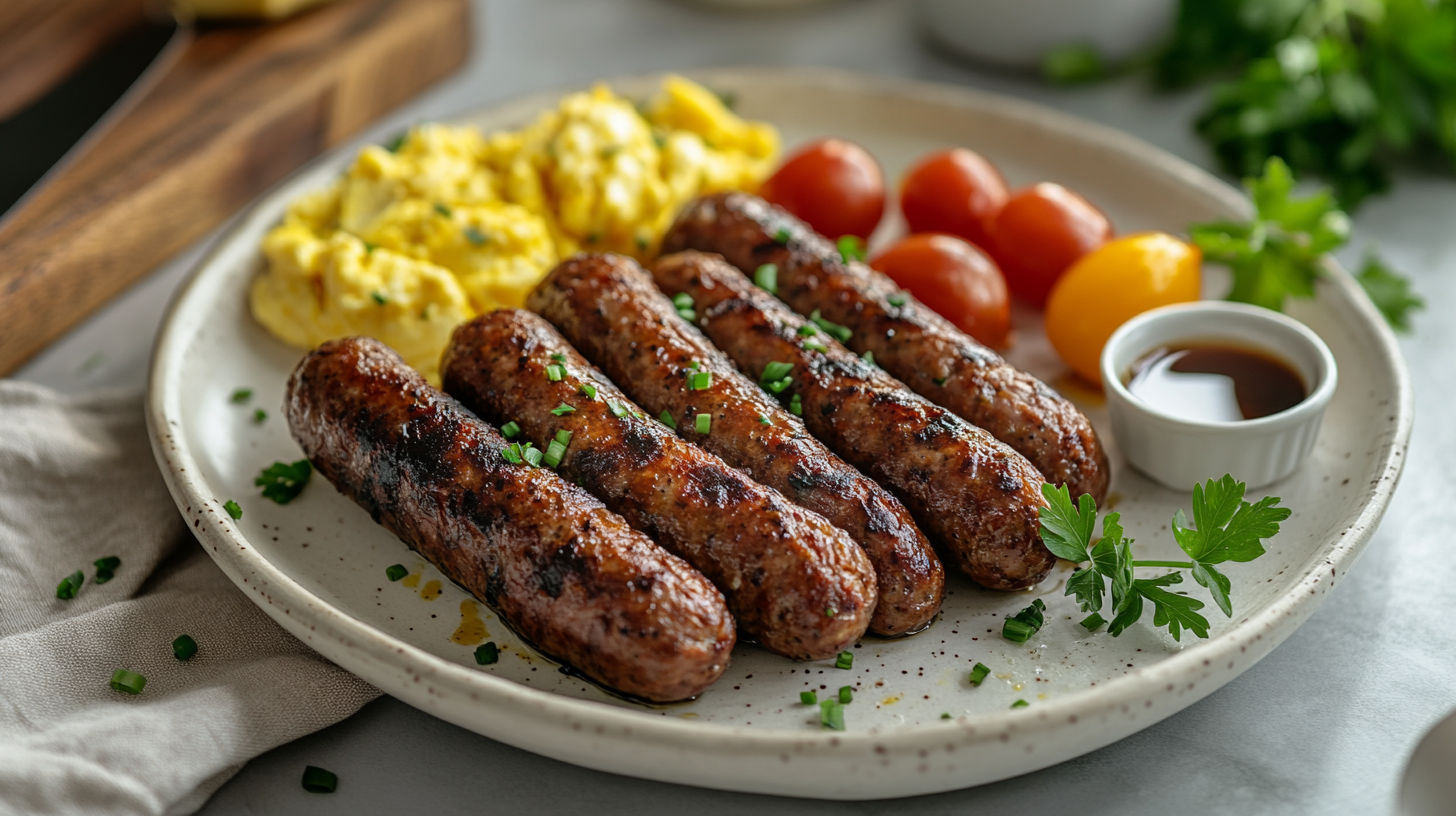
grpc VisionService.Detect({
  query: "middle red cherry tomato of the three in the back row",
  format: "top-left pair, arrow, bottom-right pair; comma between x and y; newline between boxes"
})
900,147 -> 1009,246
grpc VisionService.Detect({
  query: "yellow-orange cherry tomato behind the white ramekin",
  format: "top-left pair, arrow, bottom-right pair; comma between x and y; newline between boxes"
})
1047,232 -> 1203,383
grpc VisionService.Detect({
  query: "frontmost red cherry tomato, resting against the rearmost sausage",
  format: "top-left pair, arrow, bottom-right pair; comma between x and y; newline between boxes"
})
869,233 -> 1010,348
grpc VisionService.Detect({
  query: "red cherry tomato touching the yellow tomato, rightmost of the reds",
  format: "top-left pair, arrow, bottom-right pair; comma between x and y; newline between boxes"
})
987,182 -> 1112,309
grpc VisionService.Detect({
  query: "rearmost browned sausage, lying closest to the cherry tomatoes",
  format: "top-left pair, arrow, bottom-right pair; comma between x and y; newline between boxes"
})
662,192 -> 1111,503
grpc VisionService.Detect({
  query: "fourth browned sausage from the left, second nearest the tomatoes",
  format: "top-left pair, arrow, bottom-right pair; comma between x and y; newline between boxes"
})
652,252 -> 1056,589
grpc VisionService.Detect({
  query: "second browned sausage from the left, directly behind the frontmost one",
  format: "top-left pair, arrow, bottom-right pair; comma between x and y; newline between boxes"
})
441,309 -> 875,660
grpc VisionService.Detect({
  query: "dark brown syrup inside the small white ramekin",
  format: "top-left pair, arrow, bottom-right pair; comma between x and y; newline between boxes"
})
1125,342 -> 1309,423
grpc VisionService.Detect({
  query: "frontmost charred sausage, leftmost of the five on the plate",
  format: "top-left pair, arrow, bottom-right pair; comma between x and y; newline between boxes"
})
285,338 -> 735,702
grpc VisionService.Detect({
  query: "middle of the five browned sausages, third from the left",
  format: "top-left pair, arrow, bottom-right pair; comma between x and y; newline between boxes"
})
527,255 -> 945,635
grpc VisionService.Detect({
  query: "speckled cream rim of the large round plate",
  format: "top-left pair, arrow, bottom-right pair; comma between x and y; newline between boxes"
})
147,68 -> 1414,800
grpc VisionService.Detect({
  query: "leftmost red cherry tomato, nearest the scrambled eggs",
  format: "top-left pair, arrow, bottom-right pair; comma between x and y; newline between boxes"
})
759,138 -> 885,239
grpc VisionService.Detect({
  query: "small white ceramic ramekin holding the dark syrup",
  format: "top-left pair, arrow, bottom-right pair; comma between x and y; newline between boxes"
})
1102,300 -> 1337,490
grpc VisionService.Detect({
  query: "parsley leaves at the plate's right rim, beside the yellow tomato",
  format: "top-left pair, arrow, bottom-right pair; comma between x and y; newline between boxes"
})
1188,157 -> 1425,331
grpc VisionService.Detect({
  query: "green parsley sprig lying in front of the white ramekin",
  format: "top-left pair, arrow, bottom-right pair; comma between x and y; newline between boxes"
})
1041,475 -> 1290,640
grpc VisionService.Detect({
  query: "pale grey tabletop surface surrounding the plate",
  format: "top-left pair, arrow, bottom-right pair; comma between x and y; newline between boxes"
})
17,0 -> 1456,816
